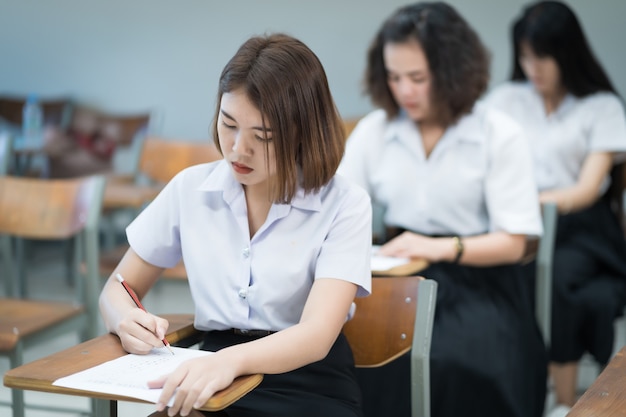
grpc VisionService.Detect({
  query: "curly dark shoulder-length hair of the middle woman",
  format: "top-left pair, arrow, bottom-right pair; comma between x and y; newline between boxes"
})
365,2 -> 490,126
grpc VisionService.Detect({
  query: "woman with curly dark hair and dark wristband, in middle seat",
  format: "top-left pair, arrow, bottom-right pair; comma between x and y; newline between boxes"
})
339,2 -> 547,417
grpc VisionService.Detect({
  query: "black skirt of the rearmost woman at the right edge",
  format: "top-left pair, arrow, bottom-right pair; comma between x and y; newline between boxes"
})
550,200 -> 626,365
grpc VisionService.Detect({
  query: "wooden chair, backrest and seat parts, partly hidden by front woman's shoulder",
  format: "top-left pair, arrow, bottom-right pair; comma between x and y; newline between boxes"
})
100,137 -> 222,279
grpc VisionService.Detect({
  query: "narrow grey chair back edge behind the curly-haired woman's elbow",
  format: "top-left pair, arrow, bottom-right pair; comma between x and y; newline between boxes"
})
535,203 -> 558,346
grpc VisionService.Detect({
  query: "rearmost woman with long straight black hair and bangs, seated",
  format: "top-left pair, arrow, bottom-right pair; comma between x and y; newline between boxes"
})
487,1 -> 626,415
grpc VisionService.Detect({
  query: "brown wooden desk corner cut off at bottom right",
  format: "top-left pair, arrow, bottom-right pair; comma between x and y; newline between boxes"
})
567,346 -> 626,417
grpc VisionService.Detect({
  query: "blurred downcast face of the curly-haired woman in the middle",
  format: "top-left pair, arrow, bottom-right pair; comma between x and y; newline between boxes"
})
383,39 -> 433,122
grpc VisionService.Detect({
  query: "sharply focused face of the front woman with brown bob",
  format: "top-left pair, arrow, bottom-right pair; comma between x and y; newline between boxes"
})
217,90 -> 276,193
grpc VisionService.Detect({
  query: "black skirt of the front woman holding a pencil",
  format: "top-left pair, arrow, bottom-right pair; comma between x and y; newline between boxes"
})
195,331 -> 363,417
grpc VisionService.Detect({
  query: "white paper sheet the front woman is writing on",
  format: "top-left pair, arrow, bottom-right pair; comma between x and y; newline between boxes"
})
53,346 -> 213,406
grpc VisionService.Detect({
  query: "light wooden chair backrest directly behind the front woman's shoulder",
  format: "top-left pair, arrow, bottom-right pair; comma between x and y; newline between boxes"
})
139,137 -> 222,184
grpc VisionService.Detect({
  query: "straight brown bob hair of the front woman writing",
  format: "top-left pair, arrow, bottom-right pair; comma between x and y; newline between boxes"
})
212,34 -> 345,203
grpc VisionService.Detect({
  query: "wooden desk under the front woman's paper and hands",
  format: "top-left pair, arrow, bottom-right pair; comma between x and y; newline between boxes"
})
4,314 -> 263,417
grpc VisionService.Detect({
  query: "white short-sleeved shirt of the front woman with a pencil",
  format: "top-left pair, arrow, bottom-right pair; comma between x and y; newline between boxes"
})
127,160 -> 371,330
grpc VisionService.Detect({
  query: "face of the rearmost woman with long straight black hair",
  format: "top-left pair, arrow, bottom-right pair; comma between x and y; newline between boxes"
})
518,42 -> 562,96
